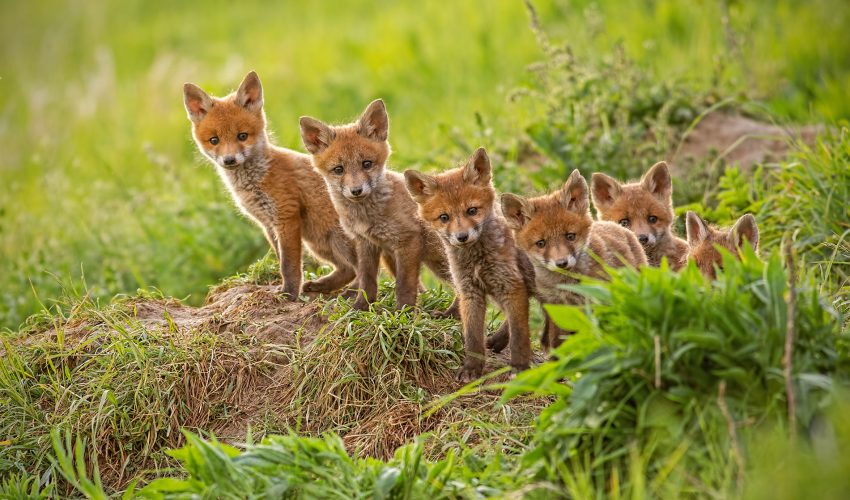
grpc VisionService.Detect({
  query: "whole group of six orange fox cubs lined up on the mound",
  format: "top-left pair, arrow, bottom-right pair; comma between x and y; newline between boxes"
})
183,71 -> 758,381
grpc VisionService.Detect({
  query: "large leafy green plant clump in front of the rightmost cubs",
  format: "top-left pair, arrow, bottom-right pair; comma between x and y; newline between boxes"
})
505,250 -> 850,491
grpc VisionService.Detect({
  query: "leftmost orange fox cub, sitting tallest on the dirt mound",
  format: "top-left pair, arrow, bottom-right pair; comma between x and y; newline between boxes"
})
183,71 -> 357,298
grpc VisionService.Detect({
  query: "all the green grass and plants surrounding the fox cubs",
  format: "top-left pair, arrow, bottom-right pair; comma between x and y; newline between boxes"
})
0,0 -> 850,498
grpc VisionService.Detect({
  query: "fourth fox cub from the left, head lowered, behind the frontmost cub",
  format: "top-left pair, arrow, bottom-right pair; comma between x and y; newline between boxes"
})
502,170 -> 646,348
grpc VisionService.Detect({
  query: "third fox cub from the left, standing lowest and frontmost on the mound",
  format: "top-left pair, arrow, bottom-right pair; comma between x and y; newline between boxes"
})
404,148 -> 534,381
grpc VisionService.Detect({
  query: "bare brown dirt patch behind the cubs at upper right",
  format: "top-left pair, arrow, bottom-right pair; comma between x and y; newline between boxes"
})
669,111 -> 823,169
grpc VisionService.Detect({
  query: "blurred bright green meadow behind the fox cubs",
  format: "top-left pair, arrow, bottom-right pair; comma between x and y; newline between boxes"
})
0,0 -> 850,328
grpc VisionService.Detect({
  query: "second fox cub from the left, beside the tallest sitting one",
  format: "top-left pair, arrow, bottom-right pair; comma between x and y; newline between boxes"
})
301,99 -> 455,314
